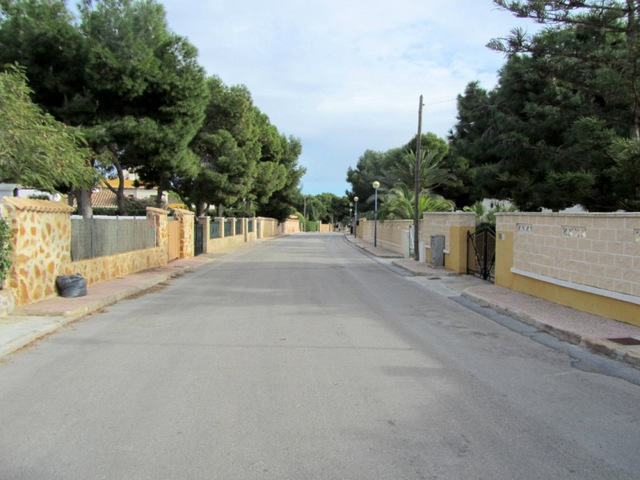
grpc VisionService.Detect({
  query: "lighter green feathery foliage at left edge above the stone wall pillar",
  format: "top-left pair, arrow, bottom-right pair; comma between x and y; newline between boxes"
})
0,66 -> 96,192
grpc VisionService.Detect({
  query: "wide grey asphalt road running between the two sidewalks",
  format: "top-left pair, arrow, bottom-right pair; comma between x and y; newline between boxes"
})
0,235 -> 640,480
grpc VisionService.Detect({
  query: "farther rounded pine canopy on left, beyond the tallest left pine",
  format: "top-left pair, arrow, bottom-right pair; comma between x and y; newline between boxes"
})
175,77 -> 304,219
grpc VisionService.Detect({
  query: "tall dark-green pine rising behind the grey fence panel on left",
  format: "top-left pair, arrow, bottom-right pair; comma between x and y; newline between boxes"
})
80,0 -> 209,210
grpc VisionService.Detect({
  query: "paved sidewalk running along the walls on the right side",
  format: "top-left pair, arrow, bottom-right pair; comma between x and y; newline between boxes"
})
346,234 -> 640,368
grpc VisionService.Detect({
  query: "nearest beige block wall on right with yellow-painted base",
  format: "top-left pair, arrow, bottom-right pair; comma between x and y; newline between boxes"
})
496,213 -> 640,325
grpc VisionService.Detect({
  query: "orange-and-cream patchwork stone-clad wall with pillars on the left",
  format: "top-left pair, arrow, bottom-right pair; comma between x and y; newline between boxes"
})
0,197 -> 180,316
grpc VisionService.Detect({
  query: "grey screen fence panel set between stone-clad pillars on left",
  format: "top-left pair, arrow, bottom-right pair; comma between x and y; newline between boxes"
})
71,217 -> 156,261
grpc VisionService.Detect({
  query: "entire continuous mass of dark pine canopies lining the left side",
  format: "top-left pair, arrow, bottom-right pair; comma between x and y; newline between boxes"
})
0,0 -> 304,216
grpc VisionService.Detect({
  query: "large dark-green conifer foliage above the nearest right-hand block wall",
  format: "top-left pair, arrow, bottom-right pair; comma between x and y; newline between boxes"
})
450,0 -> 640,211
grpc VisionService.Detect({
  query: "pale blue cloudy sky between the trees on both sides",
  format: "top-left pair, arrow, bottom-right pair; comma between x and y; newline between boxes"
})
161,0 -> 535,195
